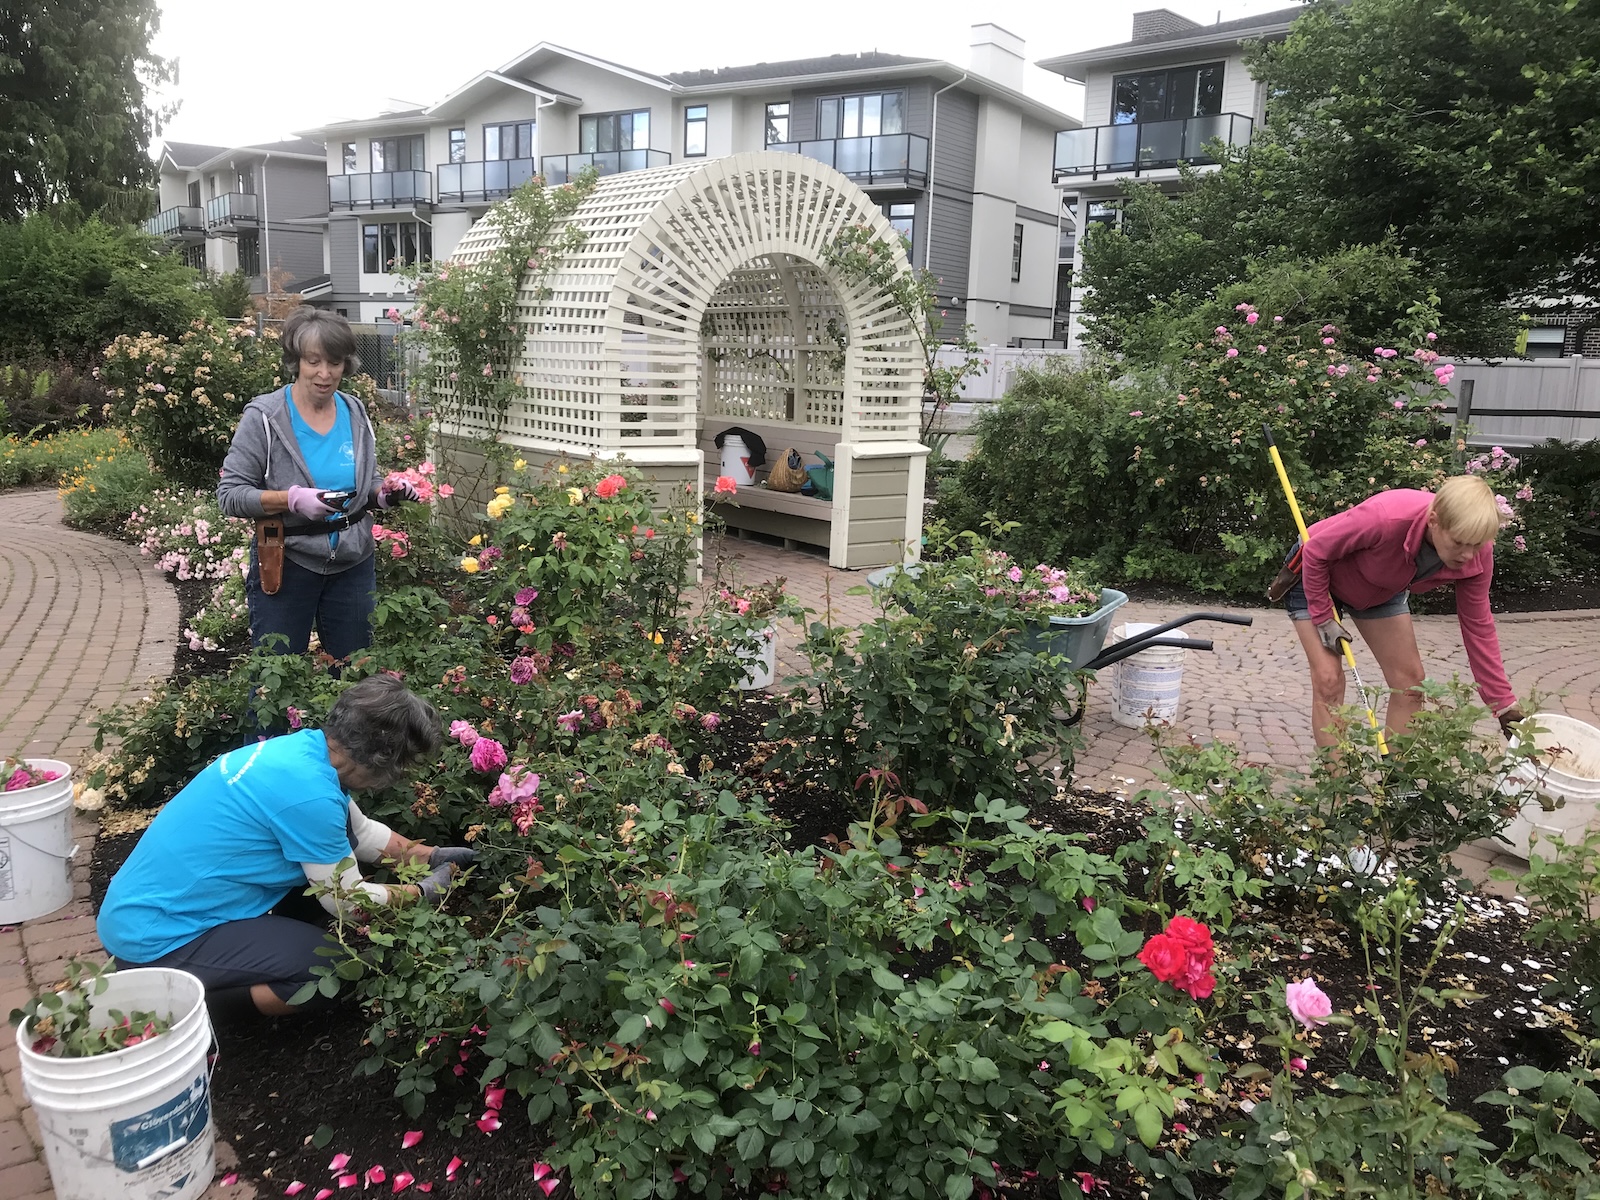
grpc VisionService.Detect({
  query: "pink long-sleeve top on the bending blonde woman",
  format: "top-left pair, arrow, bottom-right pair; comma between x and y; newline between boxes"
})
1301,488 -> 1517,715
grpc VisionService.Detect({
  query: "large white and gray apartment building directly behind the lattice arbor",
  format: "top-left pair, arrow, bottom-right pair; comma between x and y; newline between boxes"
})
306,24 -> 1077,344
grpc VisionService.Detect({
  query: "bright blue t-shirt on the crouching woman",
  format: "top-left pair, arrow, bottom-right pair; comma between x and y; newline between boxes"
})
98,730 -> 350,963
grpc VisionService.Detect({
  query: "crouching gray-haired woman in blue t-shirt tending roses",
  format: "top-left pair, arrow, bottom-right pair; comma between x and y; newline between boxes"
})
98,675 -> 474,1016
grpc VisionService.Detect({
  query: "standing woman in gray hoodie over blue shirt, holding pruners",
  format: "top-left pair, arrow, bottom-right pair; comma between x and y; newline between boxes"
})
216,307 -> 418,659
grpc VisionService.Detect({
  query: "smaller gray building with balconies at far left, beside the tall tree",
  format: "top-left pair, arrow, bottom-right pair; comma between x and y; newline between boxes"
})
144,138 -> 328,291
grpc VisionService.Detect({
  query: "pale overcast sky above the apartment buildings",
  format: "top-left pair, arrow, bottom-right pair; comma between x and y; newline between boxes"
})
155,0 -> 1293,146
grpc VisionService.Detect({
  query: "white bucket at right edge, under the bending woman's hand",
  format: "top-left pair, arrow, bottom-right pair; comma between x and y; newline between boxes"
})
1482,712 -> 1600,858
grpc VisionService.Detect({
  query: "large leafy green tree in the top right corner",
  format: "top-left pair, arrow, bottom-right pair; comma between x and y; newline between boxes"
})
1251,0 -> 1600,299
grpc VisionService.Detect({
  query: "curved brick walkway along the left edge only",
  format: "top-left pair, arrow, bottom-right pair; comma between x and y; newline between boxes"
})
0,491 -> 178,1200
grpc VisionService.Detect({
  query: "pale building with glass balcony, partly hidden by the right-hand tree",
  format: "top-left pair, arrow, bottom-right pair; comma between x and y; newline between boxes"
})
1037,6 -> 1304,346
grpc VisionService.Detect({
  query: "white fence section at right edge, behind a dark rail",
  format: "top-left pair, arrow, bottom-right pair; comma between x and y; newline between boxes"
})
1450,355 -> 1600,446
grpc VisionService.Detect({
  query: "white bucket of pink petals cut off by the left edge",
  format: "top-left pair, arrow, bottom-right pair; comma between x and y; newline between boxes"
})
0,758 -> 78,925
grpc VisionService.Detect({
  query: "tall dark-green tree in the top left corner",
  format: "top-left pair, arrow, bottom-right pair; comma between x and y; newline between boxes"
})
0,0 -> 171,219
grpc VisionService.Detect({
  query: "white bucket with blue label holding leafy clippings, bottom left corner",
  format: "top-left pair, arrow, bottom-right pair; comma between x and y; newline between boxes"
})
16,966 -> 216,1200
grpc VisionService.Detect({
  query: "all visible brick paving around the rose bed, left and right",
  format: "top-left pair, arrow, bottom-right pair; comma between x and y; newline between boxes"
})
0,491 -> 1600,1200
